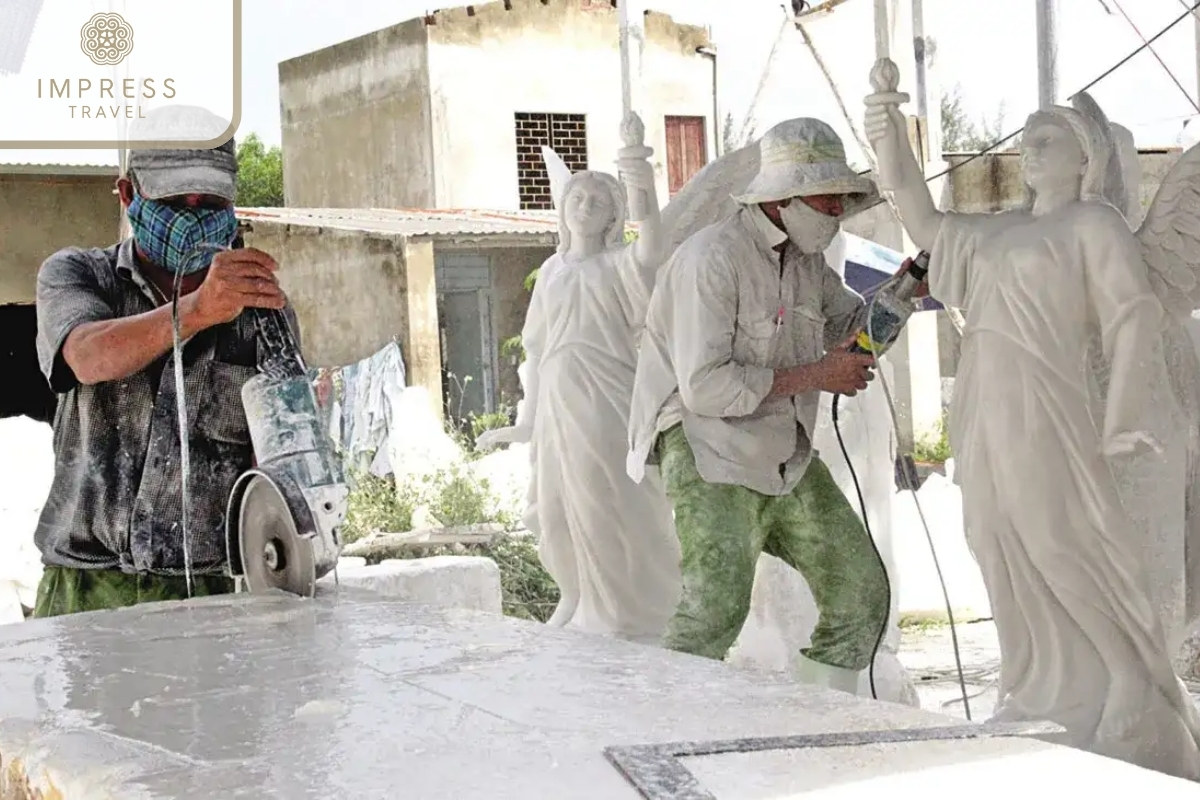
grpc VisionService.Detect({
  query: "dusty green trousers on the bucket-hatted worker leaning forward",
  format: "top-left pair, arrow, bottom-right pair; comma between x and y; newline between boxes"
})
659,426 -> 892,670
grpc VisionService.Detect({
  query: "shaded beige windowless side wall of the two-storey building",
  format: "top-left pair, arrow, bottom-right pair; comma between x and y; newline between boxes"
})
280,19 -> 434,207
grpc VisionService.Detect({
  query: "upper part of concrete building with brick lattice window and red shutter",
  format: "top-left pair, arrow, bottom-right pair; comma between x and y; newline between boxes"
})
280,0 -> 719,210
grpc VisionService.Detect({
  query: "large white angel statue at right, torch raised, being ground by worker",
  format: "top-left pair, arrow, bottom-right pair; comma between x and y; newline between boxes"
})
866,54 -> 1200,780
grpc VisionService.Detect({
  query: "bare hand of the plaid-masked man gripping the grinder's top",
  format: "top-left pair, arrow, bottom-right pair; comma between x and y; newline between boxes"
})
194,247 -> 288,327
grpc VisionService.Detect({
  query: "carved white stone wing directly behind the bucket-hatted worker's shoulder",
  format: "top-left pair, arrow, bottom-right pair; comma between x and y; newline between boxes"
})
662,142 -> 758,258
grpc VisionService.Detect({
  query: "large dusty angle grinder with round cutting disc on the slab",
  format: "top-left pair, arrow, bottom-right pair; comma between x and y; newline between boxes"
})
226,231 -> 349,597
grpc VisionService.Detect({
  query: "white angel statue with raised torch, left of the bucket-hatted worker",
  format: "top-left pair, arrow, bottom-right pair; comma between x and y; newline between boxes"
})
479,114 -> 679,643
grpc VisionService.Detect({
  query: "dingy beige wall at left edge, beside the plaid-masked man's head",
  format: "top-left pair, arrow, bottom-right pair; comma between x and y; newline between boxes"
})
0,170 -> 120,305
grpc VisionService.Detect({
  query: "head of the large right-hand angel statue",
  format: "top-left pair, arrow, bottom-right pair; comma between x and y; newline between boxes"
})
1021,106 -> 1112,200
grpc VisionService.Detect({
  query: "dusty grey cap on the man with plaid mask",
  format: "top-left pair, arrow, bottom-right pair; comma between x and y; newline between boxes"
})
127,106 -> 238,203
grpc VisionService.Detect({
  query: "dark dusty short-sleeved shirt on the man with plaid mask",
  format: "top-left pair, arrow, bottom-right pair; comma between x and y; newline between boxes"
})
35,239 -> 299,575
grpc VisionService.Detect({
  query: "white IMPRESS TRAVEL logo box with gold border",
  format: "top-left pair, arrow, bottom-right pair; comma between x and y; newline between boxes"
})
0,0 -> 242,148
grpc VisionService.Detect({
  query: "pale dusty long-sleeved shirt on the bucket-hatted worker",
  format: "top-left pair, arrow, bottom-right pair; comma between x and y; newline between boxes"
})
628,206 -> 864,495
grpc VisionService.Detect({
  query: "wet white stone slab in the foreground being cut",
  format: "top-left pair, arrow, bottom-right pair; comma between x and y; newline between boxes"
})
0,589 -> 1195,800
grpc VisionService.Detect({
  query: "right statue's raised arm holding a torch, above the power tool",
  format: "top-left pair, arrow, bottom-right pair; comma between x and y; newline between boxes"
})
864,59 -> 942,251
